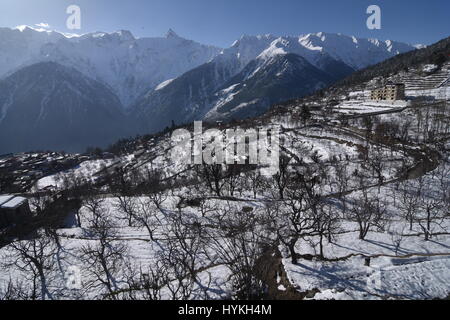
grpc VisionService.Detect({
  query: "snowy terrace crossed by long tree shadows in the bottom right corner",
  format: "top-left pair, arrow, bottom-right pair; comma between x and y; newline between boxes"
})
283,255 -> 450,300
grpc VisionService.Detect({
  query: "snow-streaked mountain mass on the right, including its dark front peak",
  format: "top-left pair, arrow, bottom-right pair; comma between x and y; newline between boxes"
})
133,32 -> 415,132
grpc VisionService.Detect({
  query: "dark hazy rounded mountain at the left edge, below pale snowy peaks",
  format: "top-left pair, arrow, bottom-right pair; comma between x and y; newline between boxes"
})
0,62 -> 128,154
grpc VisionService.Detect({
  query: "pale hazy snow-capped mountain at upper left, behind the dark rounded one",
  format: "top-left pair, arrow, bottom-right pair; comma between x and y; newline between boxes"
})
0,26 -> 220,108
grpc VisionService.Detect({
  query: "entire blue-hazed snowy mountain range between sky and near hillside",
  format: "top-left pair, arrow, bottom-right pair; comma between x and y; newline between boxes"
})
0,26 -> 416,153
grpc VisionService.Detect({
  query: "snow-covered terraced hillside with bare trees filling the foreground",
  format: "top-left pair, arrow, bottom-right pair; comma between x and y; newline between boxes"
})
0,34 -> 450,300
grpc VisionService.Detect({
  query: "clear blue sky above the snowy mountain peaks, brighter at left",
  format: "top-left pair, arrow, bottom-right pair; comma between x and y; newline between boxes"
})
0,0 -> 450,47
